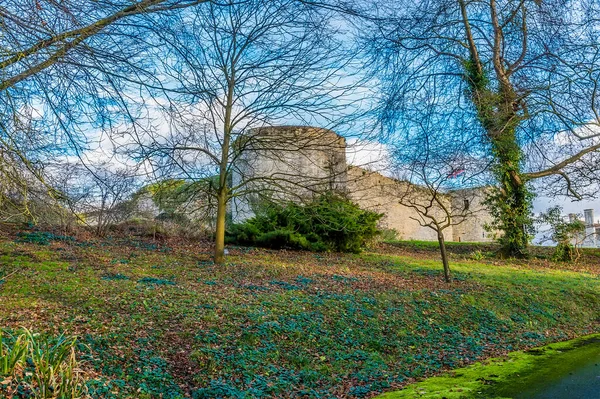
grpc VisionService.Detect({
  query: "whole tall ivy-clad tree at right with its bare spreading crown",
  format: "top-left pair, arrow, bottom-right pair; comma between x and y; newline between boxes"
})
367,0 -> 600,257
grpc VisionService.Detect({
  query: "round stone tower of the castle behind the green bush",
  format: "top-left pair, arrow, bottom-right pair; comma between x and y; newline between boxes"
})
231,126 -> 348,222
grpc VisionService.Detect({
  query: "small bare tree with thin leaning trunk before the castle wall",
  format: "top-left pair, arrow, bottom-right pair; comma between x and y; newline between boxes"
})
393,119 -> 487,282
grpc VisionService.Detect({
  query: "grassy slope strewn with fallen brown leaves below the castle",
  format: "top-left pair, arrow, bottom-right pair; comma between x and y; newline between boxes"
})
0,233 -> 600,398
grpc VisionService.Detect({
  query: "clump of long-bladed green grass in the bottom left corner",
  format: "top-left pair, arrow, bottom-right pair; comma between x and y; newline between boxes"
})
0,329 -> 87,399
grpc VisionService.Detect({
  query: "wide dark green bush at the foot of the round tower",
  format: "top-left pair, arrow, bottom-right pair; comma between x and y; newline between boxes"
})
227,193 -> 383,252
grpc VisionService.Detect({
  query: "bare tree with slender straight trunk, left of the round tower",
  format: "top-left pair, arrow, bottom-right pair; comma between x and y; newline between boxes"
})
128,0 -> 354,264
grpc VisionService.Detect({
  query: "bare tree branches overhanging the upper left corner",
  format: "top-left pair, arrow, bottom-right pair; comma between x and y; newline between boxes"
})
0,0 -> 209,220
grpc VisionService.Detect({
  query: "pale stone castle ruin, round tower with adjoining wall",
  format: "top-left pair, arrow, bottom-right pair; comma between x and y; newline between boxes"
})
231,126 -> 494,242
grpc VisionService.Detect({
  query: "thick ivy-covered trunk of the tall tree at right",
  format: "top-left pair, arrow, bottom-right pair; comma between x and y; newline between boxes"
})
459,0 -> 532,258
